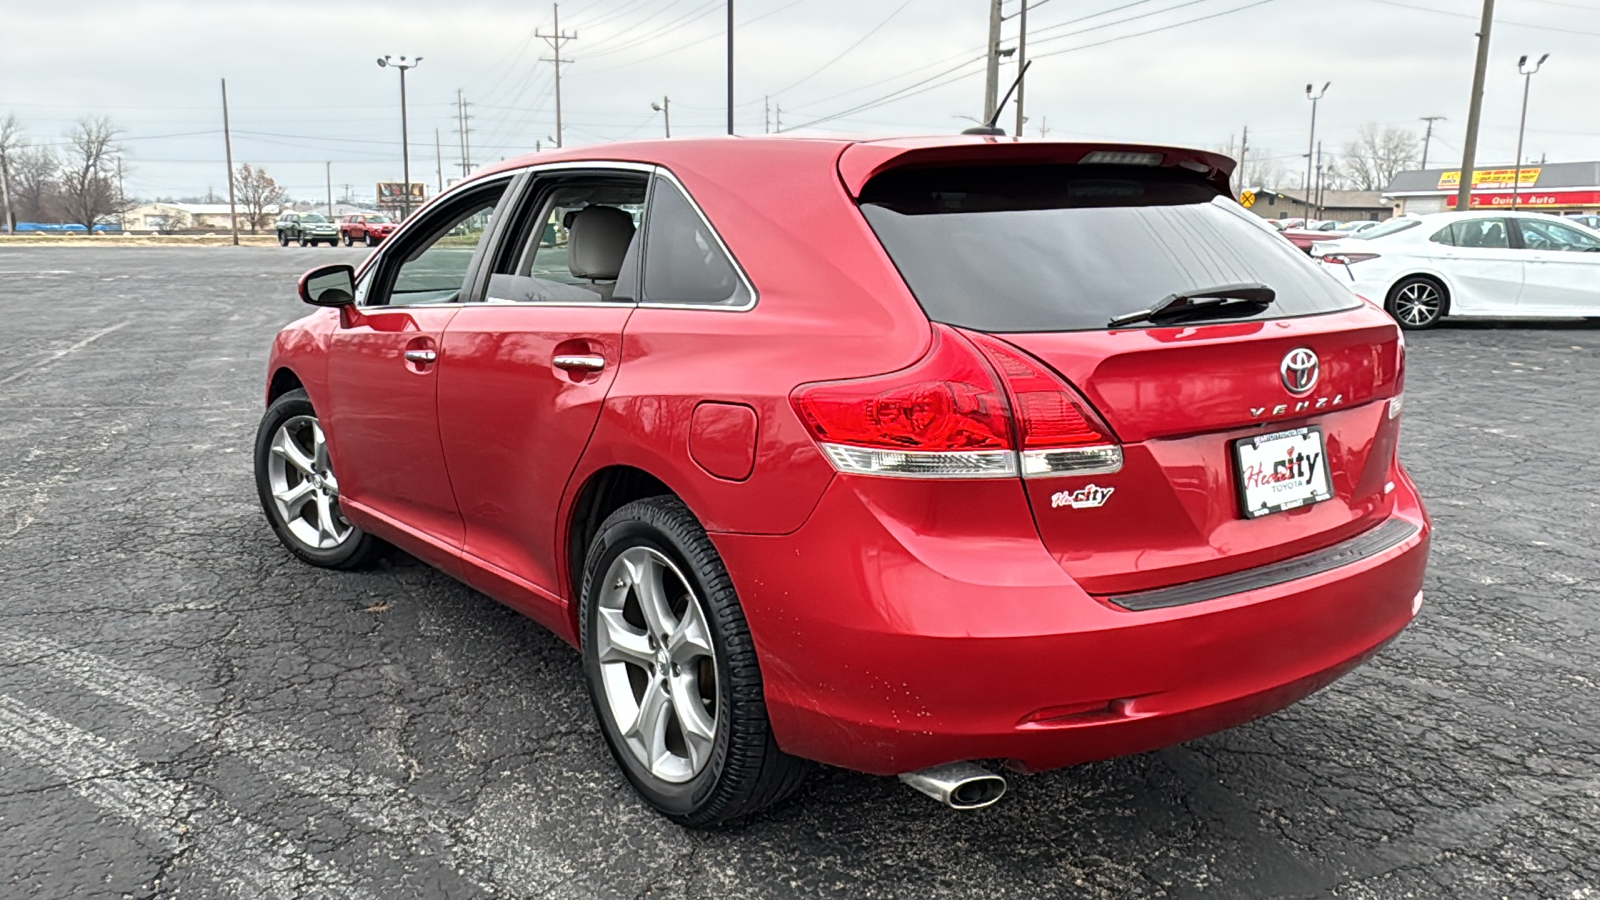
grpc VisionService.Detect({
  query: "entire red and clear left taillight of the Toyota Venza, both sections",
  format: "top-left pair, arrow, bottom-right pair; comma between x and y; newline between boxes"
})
794,325 -> 1122,479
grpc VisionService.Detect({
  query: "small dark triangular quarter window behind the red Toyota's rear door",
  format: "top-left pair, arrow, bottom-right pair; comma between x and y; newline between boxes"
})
643,178 -> 754,306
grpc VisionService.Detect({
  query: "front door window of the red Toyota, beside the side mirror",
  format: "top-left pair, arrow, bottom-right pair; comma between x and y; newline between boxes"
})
370,181 -> 507,306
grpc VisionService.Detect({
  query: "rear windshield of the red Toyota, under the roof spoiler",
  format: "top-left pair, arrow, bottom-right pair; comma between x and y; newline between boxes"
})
861,165 -> 1360,331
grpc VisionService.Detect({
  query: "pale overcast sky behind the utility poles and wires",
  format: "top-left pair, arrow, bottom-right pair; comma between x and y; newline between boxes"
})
0,0 -> 1600,200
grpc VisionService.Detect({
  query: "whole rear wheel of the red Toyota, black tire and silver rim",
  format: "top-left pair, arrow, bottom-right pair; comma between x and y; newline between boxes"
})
579,496 -> 805,828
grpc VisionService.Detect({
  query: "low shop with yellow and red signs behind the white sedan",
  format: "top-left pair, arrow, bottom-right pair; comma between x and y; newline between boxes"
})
1384,162 -> 1600,216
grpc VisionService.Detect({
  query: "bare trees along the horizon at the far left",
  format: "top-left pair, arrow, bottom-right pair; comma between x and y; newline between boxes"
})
0,114 -> 290,232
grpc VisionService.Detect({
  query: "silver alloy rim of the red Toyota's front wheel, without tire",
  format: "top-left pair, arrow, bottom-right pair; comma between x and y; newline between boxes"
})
267,416 -> 355,549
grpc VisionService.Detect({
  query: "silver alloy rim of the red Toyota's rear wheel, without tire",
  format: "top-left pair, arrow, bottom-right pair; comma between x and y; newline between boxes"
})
595,546 -> 720,783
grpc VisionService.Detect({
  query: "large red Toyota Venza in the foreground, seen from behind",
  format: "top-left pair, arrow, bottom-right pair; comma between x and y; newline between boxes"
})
256,138 -> 1429,825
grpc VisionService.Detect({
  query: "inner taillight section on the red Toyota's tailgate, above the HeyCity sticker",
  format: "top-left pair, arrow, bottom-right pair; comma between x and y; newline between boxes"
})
966,333 -> 1122,477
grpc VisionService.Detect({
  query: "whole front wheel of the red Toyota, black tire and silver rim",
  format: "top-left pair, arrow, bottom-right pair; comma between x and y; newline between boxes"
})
256,391 -> 382,569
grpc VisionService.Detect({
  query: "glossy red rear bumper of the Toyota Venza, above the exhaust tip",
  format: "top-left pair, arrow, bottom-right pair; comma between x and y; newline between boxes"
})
715,472 -> 1430,775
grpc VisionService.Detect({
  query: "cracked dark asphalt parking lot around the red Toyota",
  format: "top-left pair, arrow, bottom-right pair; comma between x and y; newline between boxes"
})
0,247 -> 1600,900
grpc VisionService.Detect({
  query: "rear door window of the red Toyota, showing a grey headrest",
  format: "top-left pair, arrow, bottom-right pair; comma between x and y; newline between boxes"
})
486,171 -> 650,303
